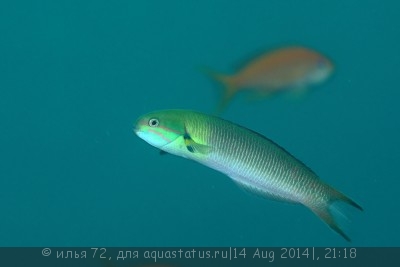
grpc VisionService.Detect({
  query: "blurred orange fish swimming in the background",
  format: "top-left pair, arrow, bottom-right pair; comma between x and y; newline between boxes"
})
200,46 -> 334,111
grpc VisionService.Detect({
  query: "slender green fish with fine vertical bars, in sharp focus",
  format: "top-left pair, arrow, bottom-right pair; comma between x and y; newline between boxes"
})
134,109 -> 363,241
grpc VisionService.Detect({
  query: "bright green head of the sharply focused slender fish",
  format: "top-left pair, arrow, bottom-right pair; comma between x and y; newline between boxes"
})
134,111 -> 185,150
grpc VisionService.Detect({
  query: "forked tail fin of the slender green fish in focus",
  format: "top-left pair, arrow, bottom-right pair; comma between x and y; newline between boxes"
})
309,189 -> 363,242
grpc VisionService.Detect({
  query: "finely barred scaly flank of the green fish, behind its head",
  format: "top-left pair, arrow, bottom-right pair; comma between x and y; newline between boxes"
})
186,110 -> 346,205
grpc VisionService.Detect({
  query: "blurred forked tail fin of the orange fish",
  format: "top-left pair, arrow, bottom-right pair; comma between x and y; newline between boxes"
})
199,67 -> 237,113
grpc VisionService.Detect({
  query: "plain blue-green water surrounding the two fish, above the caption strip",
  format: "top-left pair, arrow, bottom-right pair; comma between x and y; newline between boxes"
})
0,0 -> 400,246
